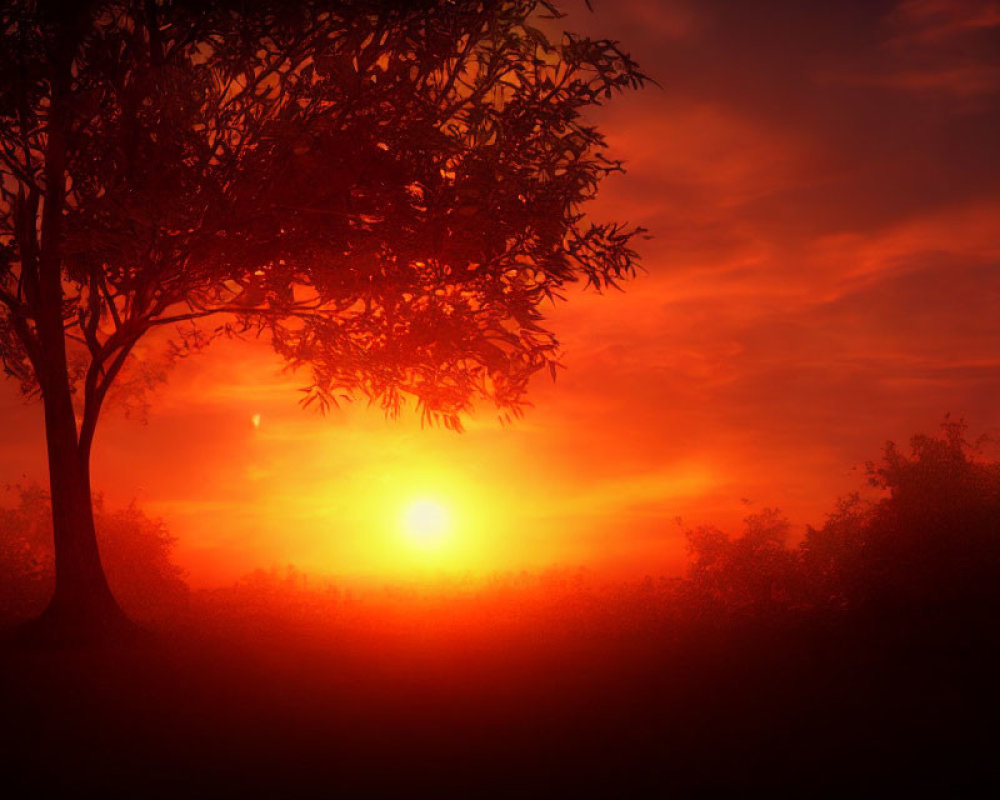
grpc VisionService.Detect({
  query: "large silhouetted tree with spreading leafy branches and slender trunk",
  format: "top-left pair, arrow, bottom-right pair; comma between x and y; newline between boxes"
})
0,0 -> 646,629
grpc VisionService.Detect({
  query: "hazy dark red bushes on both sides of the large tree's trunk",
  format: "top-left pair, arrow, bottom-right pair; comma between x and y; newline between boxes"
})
0,486 -> 189,620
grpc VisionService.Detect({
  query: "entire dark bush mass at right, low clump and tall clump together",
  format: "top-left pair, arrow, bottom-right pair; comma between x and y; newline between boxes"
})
686,421 -> 1000,616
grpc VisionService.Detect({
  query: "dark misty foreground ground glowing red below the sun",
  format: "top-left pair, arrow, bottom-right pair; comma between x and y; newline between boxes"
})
0,584 -> 1000,797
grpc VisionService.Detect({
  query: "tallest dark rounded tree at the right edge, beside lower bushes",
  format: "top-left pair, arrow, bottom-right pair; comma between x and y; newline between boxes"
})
802,420 -> 1000,623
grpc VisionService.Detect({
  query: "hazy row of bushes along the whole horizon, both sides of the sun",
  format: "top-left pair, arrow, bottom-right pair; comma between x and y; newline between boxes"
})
0,421 -> 1000,626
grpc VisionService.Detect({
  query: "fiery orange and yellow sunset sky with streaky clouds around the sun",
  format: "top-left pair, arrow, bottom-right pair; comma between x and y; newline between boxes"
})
0,0 -> 1000,584
